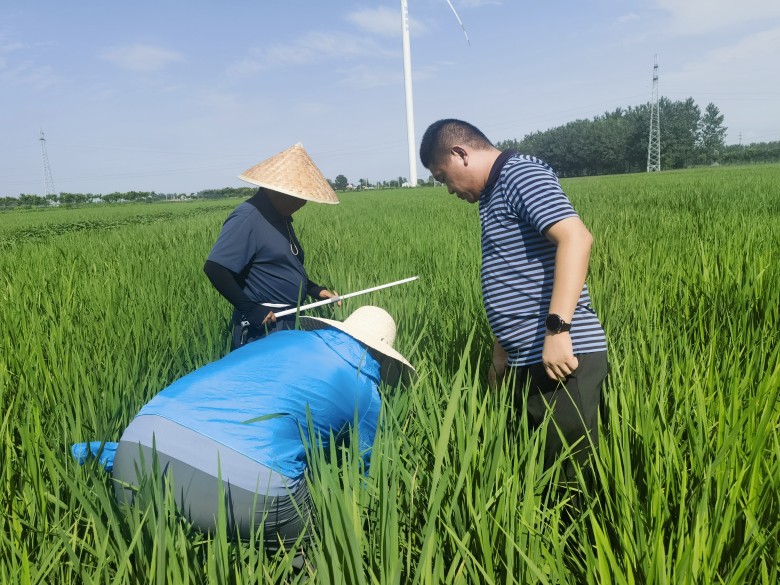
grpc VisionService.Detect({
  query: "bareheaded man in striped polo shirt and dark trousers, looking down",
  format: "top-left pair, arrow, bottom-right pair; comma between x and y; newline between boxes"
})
420,119 -> 608,478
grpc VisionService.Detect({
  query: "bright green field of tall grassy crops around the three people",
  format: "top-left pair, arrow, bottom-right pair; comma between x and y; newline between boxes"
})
0,165 -> 780,585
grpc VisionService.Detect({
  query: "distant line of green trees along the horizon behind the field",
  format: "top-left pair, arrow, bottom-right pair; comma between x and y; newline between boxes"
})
6,97 -> 780,209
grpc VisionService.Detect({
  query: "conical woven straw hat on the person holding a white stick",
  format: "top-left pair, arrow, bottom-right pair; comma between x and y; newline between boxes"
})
238,143 -> 339,205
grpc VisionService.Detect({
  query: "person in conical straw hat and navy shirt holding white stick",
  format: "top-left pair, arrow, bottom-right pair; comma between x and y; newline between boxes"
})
203,144 -> 340,349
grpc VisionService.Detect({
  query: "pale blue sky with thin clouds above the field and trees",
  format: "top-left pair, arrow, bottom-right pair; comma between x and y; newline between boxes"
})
0,0 -> 780,196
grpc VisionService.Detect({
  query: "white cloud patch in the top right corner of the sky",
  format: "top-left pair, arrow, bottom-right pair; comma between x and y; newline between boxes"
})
656,0 -> 780,35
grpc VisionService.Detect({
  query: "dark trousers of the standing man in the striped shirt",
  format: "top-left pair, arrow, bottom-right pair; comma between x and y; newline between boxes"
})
507,351 -> 608,480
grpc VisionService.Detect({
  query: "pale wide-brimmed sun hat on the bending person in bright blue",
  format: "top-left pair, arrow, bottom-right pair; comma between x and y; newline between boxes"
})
298,305 -> 416,386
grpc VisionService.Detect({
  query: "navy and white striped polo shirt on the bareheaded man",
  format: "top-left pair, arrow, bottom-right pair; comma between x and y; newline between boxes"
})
479,151 -> 607,366
